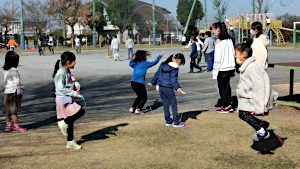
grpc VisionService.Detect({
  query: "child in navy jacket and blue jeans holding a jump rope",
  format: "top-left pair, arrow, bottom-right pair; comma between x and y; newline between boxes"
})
150,53 -> 185,127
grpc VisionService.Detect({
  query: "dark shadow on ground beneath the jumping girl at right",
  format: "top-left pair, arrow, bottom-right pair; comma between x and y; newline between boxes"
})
251,130 -> 287,154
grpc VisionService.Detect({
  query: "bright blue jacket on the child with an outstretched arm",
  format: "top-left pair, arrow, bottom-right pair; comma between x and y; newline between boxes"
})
129,55 -> 162,84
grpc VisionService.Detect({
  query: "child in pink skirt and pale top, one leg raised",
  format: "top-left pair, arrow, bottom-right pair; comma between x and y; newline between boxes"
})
53,52 -> 85,149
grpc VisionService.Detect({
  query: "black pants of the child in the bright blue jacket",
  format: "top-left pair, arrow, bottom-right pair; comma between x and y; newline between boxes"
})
131,81 -> 147,109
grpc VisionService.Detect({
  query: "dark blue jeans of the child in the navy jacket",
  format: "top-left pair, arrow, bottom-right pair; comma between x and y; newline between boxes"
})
159,86 -> 179,124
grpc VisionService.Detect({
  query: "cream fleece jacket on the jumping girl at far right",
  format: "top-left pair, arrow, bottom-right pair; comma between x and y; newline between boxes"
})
236,56 -> 278,114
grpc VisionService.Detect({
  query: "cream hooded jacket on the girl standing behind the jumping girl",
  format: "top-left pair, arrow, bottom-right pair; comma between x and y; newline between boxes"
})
251,34 -> 270,70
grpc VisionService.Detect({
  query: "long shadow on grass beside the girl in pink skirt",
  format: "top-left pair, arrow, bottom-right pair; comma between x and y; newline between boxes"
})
77,123 -> 129,144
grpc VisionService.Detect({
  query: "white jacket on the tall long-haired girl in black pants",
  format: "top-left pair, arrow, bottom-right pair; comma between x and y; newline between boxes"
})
212,39 -> 235,79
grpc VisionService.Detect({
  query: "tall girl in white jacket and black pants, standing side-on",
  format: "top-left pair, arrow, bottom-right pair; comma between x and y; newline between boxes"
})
212,22 -> 235,113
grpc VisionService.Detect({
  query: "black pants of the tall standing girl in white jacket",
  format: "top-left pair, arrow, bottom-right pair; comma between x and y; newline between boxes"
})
217,70 -> 234,108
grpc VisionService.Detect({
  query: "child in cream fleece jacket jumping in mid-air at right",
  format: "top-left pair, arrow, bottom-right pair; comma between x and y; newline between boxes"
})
235,43 -> 278,141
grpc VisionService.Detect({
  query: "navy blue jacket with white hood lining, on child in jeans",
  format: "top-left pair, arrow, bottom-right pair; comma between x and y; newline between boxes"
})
151,62 -> 180,90
